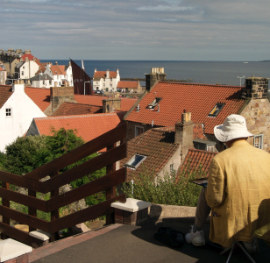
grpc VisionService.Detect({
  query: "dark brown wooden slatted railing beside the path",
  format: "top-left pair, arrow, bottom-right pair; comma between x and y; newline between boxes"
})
0,124 -> 127,247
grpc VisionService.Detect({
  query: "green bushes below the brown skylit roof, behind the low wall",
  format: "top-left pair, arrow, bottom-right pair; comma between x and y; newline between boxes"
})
123,167 -> 201,206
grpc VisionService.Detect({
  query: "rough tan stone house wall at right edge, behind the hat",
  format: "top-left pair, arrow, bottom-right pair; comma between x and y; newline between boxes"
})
241,99 -> 270,152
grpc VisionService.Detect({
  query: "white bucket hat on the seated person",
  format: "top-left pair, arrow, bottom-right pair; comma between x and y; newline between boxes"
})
214,114 -> 253,142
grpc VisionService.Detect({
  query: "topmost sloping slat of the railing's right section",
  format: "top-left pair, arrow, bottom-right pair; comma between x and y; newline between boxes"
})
25,123 -> 127,182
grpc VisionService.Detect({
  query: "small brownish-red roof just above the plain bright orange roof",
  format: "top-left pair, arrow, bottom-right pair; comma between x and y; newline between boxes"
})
51,102 -> 102,117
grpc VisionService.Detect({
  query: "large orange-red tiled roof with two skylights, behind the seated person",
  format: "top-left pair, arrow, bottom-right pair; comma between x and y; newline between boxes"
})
125,82 -> 245,134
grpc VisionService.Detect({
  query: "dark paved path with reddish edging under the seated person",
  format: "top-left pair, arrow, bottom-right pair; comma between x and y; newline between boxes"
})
30,219 -> 270,263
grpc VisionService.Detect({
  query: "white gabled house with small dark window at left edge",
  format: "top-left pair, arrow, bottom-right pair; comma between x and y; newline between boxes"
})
0,80 -> 46,152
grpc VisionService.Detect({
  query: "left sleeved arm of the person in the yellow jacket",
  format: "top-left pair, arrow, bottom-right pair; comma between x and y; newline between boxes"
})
205,158 -> 225,208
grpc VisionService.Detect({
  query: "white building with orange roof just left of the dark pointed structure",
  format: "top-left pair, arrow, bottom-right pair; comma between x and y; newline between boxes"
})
44,62 -> 73,87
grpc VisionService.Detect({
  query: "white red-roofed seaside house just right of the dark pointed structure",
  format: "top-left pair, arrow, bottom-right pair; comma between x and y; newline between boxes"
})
93,69 -> 120,92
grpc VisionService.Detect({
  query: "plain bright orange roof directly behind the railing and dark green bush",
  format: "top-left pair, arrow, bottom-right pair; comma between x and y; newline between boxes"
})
34,113 -> 123,147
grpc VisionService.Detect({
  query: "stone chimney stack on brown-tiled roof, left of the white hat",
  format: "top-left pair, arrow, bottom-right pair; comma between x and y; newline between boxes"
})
174,110 -> 194,162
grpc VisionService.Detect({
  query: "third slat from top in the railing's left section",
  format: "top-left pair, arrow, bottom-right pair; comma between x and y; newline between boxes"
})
0,205 -> 49,232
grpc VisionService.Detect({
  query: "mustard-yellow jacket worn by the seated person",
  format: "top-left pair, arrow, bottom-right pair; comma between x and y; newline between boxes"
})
205,140 -> 270,247
